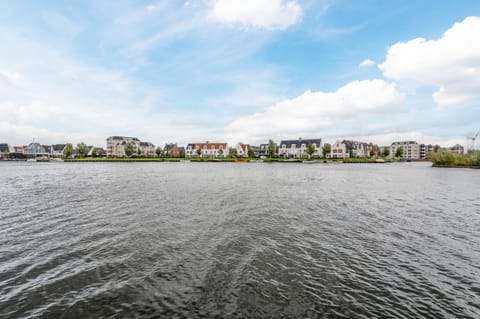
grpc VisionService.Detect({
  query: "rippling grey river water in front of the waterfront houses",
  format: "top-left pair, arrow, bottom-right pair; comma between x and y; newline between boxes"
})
0,162 -> 480,318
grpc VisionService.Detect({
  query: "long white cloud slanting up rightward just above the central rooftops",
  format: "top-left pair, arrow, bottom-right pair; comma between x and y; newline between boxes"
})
225,80 -> 404,142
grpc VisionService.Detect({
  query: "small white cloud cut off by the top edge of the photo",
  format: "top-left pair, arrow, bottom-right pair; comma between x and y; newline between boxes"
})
209,0 -> 302,30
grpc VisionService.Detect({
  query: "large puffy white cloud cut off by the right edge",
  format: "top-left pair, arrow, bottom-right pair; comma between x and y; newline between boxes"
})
379,17 -> 480,106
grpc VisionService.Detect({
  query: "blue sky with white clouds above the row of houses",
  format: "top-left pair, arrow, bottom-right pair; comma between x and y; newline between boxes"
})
0,0 -> 480,146
